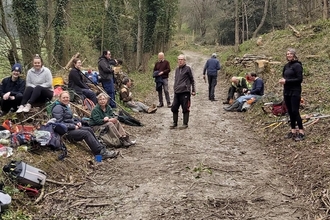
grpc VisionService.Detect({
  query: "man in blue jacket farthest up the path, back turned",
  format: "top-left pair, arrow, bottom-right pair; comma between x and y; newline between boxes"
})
203,53 -> 221,102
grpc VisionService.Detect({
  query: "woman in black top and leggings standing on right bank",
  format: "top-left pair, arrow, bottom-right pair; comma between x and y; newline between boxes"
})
279,48 -> 305,141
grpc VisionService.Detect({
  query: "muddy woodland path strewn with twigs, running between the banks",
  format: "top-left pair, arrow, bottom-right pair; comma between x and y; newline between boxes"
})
37,51 -> 307,220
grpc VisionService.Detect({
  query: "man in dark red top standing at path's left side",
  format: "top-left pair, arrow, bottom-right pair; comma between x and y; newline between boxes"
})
154,52 -> 171,108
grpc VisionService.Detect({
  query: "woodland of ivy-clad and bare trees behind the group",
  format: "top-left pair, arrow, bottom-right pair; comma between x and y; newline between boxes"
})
0,0 -> 329,74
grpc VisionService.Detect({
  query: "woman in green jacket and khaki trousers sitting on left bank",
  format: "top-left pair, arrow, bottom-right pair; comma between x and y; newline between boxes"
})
89,93 -> 134,147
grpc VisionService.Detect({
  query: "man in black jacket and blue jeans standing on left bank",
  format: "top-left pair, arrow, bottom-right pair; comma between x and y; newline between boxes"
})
98,50 -> 118,108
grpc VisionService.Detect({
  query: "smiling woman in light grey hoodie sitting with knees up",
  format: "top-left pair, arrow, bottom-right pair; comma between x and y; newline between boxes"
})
16,54 -> 54,113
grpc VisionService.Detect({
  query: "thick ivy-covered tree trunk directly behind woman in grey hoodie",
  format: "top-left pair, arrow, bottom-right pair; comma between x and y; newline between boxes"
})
13,0 -> 41,68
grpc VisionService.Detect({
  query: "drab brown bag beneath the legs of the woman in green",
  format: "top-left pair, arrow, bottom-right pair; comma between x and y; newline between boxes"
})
95,122 -> 122,147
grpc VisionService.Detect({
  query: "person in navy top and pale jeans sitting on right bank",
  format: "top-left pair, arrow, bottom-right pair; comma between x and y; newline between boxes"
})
223,73 -> 264,112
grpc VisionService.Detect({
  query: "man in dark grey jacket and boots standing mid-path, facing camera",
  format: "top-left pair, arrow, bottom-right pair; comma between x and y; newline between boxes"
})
170,54 -> 196,129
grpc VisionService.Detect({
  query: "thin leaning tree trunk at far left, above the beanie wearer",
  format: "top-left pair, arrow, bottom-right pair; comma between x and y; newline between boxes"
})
0,0 -> 20,66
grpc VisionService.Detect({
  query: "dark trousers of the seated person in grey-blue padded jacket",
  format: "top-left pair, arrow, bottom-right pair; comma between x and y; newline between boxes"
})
67,127 -> 104,155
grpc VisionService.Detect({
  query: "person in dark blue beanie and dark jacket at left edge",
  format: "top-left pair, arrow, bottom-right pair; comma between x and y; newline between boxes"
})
0,63 -> 25,115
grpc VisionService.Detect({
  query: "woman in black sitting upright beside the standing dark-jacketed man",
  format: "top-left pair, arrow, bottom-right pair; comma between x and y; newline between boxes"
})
68,58 -> 97,104
